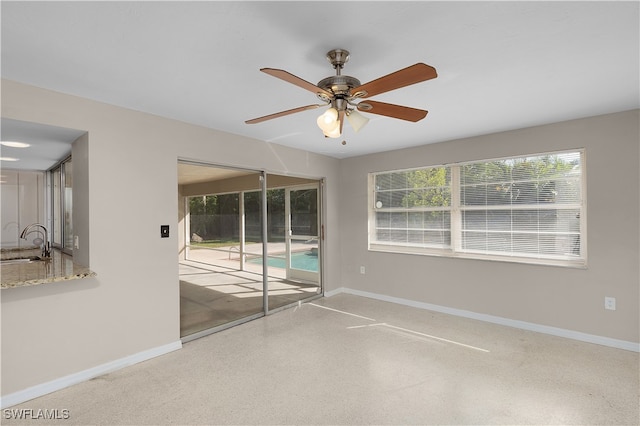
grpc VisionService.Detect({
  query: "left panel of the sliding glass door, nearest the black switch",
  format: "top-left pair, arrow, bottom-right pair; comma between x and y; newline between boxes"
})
179,164 -> 265,341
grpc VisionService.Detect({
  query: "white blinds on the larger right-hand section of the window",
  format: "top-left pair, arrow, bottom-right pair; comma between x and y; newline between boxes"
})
459,152 -> 582,259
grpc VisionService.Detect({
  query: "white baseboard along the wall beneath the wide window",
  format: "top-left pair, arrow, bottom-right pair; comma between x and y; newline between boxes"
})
324,287 -> 640,352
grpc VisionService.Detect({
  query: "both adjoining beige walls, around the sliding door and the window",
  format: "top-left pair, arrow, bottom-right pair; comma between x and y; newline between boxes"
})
1,76 -> 640,395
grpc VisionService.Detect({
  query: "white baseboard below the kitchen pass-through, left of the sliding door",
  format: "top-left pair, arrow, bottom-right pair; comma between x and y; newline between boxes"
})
0,340 -> 182,408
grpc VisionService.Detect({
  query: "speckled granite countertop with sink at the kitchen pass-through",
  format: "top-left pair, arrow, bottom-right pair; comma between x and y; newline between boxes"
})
0,248 -> 96,289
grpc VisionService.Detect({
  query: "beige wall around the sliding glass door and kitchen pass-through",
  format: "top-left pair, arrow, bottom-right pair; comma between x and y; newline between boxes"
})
1,80 -> 341,395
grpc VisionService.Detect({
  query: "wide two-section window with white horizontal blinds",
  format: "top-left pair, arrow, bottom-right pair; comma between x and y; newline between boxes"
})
369,151 -> 586,266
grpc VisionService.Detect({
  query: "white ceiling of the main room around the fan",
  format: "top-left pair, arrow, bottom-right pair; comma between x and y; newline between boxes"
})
0,1 -> 640,158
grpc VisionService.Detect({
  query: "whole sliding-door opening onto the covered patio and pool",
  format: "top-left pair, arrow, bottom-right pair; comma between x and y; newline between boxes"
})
178,160 -> 322,341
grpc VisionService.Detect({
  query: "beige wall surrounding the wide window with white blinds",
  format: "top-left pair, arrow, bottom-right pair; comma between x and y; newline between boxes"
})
339,110 -> 640,342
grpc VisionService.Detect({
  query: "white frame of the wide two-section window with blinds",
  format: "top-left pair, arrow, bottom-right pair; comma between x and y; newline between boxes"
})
367,148 -> 587,268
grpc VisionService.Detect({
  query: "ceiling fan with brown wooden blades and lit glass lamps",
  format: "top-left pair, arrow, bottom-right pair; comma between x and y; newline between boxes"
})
245,49 -> 438,138
